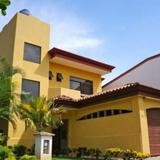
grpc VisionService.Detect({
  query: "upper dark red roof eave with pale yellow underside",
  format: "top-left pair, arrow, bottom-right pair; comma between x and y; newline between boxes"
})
48,48 -> 115,75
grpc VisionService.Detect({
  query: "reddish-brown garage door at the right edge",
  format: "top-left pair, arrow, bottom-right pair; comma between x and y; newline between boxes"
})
147,109 -> 160,155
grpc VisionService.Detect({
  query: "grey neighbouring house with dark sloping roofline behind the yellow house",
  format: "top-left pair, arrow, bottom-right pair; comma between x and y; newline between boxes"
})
103,54 -> 160,90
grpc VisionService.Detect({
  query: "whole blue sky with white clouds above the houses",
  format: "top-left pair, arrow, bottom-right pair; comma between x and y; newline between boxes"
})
0,0 -> 160,83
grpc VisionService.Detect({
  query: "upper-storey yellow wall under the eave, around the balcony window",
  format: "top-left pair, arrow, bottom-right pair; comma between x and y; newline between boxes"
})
49,62 -> 102,96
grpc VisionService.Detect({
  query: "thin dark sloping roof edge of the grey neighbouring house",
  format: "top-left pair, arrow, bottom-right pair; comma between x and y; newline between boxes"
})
102,53 -> 160,88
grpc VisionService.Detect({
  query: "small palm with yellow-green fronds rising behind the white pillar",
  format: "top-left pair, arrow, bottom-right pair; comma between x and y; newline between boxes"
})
19,97 -> 64,132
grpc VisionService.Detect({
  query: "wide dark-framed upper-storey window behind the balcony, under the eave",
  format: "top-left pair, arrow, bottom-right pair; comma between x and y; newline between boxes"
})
70,77 -> 93,94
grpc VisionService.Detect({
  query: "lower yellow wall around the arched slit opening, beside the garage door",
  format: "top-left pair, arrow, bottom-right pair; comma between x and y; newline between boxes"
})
65,97 -> 145,151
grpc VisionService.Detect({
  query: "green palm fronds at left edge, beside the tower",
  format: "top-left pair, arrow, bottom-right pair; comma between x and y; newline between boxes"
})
0,58 -> 22,128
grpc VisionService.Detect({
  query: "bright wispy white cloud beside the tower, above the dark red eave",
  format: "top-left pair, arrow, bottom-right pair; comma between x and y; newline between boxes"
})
51,16 -> 102,51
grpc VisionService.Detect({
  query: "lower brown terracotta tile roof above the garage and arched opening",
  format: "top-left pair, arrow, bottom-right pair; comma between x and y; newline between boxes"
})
53,83 -> 160,108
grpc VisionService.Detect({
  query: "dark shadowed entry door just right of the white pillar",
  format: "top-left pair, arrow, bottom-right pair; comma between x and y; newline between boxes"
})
52,120 -> 68,153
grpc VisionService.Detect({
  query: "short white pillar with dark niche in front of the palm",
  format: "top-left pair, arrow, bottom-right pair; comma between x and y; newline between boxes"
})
35,132 -> 54,160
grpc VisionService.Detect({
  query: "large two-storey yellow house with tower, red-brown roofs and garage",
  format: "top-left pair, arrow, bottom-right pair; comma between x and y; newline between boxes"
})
0,11 -> 160,154
